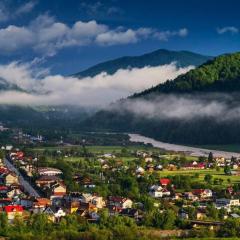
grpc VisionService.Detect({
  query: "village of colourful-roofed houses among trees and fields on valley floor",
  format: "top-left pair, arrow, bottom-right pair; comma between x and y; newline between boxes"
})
0,142 -> 240,238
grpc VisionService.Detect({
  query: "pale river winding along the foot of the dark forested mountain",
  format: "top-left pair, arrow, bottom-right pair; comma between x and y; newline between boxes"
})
128,134 -> 240,158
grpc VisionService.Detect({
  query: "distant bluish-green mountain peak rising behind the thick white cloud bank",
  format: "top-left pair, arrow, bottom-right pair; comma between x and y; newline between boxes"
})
74,49 -> 212,78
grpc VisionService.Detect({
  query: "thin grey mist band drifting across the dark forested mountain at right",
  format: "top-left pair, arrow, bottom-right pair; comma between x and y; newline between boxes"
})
107,93 -> 240,122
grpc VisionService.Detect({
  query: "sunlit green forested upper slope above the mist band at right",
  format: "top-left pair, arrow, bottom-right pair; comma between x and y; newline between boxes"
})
135,53 -> 240,97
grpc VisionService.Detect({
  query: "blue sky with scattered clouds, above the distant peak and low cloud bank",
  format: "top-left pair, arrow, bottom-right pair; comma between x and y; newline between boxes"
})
0,0 -> 240,75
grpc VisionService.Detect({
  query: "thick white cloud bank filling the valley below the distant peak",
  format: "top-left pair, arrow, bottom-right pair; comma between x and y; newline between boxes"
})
0,62 -> 192,106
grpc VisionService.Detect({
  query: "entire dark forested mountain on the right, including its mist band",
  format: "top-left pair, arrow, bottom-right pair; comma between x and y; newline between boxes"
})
85,53 -> 240,144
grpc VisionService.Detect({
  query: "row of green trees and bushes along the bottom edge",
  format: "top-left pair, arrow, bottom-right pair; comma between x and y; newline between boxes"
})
0,208 -> 240,240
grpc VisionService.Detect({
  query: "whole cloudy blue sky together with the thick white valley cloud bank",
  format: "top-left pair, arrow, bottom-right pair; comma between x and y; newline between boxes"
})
0,0 -> 240,106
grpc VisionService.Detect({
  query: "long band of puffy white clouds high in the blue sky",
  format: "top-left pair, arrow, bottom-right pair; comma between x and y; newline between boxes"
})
0,14 -> 187,56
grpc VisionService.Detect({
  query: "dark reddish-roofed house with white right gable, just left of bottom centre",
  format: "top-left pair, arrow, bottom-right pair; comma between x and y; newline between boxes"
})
107,196 -> 133,212
